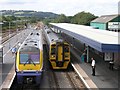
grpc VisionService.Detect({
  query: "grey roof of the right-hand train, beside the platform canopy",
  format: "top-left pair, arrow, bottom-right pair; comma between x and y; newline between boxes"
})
45,28 -> 63,43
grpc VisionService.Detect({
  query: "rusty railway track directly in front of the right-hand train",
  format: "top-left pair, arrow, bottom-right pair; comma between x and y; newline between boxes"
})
46,70 -> 86,90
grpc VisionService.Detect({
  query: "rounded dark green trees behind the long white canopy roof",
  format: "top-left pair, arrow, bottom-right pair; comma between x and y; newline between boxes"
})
44,11 -> 98,26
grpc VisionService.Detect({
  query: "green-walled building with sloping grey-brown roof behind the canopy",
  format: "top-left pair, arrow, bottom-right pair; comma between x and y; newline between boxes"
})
90,14 -> 120,32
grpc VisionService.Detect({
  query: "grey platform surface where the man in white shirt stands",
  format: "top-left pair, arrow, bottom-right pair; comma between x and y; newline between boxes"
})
71,48 -> 119,90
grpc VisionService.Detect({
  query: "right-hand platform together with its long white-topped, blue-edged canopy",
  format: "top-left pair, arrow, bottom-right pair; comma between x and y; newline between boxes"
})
50,23 -> 120,90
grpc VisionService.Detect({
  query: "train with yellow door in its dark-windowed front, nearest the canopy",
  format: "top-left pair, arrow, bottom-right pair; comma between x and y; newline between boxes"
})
43,28 -> 70,69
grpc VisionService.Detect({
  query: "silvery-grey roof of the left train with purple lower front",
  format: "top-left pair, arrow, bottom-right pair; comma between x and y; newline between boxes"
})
20,30 -> 42,49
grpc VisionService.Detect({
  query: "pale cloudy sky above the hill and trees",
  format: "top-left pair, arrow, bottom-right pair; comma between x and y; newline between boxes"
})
0,0 -> 120,16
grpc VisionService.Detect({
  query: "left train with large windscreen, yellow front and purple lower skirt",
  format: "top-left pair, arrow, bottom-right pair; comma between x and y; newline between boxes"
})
15,30 -> 43,84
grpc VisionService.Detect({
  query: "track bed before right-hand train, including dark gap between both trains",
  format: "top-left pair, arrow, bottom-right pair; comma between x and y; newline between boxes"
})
44,45 -> 85,90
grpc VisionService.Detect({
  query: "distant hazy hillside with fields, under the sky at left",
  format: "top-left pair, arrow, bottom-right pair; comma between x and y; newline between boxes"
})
0,10 -> 58,18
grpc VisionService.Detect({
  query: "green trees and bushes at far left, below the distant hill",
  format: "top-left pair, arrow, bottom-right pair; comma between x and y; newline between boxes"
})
0,15 -> 37,30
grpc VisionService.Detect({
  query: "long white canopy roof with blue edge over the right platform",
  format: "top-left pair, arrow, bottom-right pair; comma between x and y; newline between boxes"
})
51,23 -> 120,52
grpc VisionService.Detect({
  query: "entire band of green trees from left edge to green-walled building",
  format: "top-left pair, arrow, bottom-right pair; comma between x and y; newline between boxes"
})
0,11 -> 97,30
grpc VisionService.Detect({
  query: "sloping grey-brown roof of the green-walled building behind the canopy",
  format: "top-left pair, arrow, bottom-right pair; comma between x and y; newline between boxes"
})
91,14 -> 119,23
